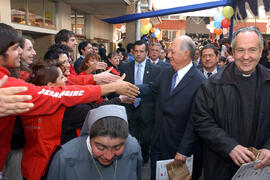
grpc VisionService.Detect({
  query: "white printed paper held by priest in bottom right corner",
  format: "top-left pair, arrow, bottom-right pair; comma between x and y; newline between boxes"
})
232,162 -> 270,180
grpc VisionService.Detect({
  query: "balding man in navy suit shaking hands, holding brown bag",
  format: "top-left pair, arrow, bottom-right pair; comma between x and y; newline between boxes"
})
151,36 -> 205,180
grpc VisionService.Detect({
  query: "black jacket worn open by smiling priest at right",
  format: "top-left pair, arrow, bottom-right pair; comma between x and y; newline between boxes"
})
192,63 -> 270,180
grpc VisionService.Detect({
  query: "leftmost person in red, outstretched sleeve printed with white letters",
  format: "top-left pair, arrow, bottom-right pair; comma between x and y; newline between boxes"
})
0,23 -> 139,172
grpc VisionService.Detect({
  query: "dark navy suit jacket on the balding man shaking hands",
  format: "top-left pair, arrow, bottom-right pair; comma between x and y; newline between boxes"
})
152,65 -> 205,159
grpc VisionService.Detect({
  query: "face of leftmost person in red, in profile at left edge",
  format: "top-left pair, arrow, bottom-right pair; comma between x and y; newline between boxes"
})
0,43 -> 23,68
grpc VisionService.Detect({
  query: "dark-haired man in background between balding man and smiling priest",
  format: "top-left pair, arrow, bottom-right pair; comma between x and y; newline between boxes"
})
200,44 -> 220,78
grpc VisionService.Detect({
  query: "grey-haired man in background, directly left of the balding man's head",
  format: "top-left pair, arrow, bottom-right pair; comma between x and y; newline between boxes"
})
149,43 -> 170,67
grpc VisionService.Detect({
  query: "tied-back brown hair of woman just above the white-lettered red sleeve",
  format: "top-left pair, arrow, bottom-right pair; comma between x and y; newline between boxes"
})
27,61 -> 60,86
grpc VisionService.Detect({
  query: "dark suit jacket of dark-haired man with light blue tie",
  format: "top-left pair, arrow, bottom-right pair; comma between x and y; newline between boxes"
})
120,60 -> 161,124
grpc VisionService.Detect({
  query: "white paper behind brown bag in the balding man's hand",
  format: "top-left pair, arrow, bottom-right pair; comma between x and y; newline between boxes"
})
156,155 -> 193,180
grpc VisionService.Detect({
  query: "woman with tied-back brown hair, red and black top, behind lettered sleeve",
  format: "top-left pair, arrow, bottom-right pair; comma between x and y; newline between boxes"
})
22,61 -> 134,180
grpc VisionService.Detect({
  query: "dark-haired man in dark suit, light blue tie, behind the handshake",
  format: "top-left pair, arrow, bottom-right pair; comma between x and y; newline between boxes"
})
120,40 -> 160,163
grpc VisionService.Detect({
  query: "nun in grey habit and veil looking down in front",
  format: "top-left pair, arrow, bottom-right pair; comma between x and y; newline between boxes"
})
48,105 -> 142,180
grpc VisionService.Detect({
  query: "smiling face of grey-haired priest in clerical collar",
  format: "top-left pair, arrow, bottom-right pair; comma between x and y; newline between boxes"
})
233,31 -> 262,74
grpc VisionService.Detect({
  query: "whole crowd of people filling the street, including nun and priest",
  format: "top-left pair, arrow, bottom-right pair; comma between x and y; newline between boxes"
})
0,23 -> 270,180
